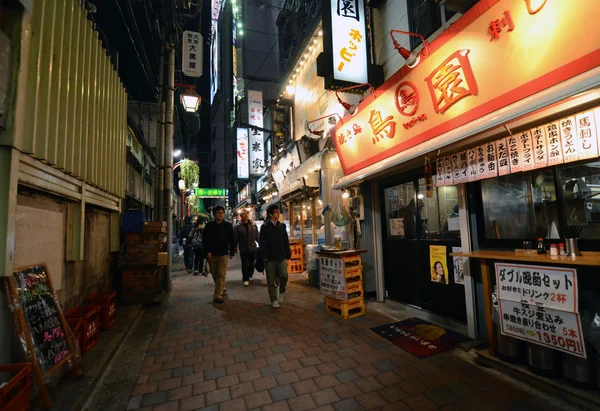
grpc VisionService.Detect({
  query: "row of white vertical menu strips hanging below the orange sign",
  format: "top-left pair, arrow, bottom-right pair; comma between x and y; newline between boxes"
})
435,107 -> 600,186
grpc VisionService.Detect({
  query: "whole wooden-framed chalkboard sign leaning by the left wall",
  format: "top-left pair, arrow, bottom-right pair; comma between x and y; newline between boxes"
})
4,264 -> 81,407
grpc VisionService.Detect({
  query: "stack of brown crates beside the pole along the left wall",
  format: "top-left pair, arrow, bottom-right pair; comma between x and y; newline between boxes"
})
120,221 -> 169,303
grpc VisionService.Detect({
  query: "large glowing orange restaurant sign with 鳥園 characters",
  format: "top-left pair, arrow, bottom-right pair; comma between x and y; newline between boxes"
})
335,0 -> 600,174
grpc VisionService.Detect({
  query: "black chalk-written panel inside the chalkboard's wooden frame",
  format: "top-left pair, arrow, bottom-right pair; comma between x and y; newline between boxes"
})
13,265 -> 69,373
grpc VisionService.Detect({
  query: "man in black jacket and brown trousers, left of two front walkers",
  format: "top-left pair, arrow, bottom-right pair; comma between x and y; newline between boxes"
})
202,205 -> 237,304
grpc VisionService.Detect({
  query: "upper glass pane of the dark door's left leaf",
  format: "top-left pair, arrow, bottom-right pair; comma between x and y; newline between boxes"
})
384,181 -> 417,239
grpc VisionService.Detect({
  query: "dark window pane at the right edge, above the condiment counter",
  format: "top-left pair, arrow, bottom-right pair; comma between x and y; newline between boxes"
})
559,162 -> 600,239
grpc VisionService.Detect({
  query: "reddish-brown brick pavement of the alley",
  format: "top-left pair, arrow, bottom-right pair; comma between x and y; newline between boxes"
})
123,257 -> 572,411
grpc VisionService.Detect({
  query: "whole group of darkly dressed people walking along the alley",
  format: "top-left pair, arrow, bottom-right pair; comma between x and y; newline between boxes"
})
180,205 -> 291,308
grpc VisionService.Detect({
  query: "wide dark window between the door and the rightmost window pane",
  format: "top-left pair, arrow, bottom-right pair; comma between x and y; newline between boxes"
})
481,169 -> 559,240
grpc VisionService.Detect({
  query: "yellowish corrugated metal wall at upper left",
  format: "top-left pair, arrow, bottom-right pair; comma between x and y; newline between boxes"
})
14,0 -> 127,198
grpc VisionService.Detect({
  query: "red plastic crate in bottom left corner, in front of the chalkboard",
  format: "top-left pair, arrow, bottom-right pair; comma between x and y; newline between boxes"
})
0,363 -> 31,411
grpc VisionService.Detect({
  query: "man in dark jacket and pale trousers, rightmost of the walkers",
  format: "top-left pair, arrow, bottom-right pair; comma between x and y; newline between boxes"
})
259,204 -> 292,308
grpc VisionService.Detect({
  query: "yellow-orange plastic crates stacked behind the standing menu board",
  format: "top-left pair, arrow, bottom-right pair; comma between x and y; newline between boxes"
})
325,254 -> 365,320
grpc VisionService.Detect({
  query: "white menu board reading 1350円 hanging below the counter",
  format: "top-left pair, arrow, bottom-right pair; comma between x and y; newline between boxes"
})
496,263 -> 586,358
